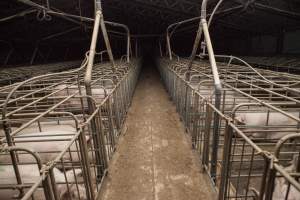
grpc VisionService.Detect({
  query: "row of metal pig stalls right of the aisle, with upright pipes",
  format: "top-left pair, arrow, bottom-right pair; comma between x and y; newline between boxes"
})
159,0 -> 300,200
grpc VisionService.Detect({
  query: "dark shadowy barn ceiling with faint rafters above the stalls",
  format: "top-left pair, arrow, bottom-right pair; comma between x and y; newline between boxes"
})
0,0 -> 300,64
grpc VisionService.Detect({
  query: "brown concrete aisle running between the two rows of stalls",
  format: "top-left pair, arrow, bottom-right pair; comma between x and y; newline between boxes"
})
100,65 -> 214,200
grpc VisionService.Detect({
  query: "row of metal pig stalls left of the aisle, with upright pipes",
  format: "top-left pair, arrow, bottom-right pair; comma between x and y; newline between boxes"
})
0,0 -> 140,200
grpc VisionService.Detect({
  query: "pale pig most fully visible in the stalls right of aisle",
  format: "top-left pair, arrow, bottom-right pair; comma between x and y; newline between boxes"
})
235,112 -> 299,139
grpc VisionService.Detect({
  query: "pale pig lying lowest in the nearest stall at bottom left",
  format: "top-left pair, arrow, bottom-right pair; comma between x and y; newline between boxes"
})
0,165 -> 87,200
